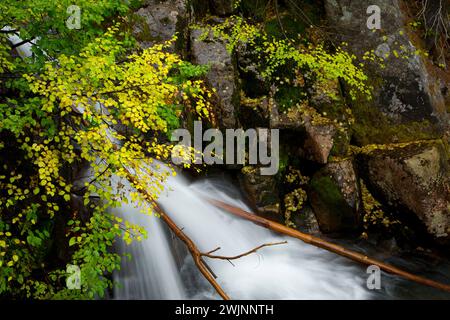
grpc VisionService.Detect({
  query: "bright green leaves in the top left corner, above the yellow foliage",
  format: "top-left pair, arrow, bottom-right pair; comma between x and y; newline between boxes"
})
0,0 -> 137,58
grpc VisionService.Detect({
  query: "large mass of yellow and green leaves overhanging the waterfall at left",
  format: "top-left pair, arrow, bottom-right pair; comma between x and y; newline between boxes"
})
0,10 -> 211,299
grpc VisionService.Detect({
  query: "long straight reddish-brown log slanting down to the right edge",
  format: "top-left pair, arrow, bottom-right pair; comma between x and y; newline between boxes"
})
207,199 -> 450,292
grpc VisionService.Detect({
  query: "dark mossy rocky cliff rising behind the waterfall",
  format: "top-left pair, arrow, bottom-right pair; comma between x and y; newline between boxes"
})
135,0 -> 450,244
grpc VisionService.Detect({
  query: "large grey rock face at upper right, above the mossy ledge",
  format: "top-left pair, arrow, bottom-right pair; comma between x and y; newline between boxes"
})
325,0 -> 448,144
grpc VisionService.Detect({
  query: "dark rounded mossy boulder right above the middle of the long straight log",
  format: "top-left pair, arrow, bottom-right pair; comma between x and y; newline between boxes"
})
308,159 -> 362,233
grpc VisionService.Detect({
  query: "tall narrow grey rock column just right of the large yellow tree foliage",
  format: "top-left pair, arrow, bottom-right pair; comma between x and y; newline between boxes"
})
191,30 -> 240,129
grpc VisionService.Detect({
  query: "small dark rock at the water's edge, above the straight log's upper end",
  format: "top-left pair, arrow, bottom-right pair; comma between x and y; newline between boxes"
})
239,166 -> 283,222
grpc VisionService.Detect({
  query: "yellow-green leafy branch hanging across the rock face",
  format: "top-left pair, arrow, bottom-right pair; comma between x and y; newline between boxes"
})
194,16 -> 371,99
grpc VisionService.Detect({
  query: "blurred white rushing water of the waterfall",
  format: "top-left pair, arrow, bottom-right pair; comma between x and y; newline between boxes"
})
114,168 -> 370,299
